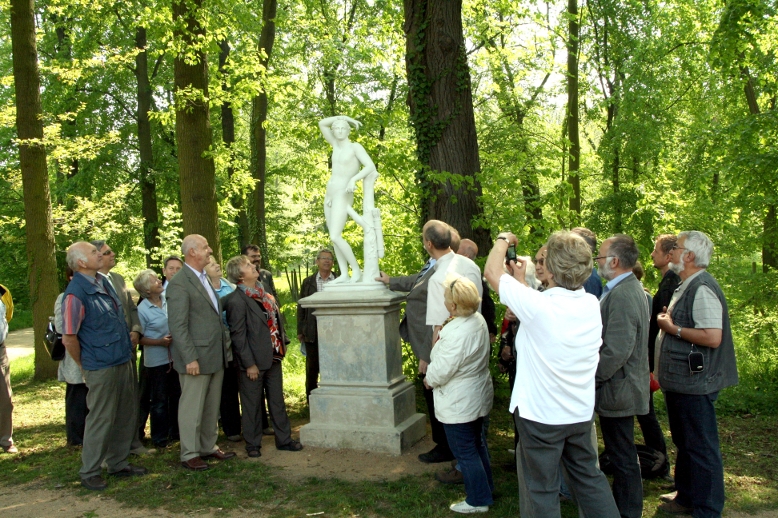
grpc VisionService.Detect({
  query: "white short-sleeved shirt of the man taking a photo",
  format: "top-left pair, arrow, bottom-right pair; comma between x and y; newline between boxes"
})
500,274 -> 602,425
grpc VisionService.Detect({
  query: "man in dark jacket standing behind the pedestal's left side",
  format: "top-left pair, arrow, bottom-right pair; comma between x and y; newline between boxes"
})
297,248 -> 337,398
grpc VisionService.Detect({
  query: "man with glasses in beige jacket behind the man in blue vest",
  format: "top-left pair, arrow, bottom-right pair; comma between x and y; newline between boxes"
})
92,239 -> 149,455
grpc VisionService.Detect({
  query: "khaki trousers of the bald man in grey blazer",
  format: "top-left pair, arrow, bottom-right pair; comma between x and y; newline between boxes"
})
178,369 -> 224,462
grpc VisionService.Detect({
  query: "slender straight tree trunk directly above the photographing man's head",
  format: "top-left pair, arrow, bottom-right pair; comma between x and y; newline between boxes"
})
567,0 -> 581,216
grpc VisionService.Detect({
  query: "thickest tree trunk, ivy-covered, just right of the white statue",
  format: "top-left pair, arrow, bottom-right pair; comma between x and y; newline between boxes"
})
403,0 -> 492,250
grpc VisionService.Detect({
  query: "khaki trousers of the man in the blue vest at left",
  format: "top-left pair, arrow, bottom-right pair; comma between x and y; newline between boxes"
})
79,362 -> 137,479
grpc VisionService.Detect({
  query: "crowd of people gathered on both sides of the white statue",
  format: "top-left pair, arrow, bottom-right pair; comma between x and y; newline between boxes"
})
0,224 -> 737,517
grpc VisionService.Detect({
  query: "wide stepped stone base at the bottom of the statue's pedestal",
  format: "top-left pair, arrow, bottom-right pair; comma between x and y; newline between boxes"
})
300,380 -> 427,455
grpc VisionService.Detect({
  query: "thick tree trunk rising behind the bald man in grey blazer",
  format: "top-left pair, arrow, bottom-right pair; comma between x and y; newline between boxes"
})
173,0 -> 221,261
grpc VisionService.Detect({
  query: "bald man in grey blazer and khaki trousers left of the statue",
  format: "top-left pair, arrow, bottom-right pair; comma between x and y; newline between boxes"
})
166,234 -> 235,471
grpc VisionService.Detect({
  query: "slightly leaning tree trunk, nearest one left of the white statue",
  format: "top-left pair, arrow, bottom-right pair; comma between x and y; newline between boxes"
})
249,0 -> 278,262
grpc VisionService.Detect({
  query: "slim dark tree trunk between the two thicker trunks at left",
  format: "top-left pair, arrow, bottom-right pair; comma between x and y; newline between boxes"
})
135,27 -> 160,268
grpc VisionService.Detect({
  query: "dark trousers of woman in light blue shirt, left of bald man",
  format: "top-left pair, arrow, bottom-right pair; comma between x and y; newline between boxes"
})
145,364 -> 181,447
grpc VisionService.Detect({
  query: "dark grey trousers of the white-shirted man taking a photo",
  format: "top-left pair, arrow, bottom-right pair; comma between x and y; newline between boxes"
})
513,409 -> 620,518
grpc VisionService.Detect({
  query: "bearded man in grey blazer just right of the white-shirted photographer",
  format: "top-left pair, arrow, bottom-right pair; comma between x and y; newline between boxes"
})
594,234 -> 650,518
